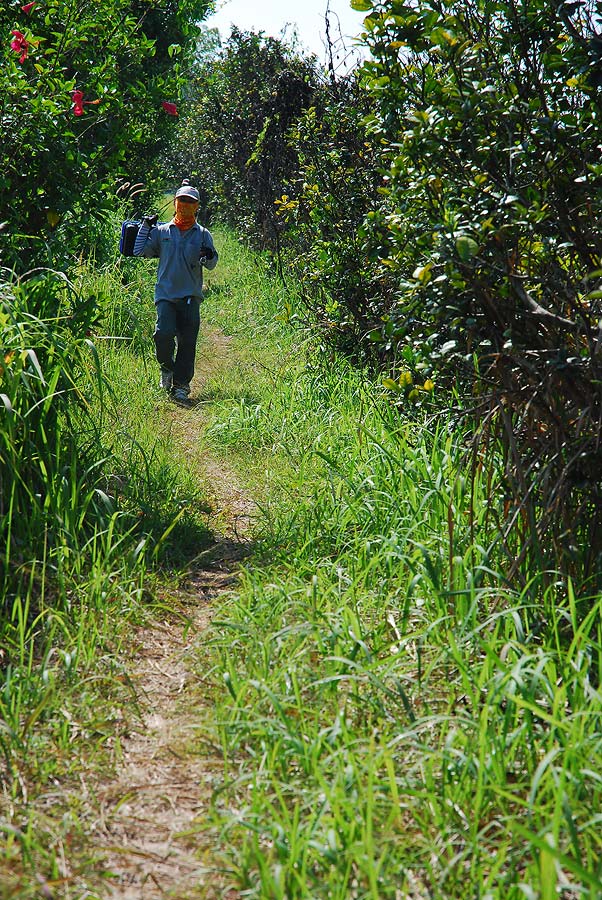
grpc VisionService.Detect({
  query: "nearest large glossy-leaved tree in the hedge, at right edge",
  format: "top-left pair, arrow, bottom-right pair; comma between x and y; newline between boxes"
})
354,0 -> 602,586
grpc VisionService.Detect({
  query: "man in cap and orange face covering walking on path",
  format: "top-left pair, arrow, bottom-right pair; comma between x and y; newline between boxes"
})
134,181 -> 218,404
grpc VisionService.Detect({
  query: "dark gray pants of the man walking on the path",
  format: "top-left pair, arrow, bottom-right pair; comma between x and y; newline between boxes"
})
154,297 -> 201,388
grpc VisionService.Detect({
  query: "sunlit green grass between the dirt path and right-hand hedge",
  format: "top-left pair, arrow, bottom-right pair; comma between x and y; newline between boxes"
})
196,248 -> 602,900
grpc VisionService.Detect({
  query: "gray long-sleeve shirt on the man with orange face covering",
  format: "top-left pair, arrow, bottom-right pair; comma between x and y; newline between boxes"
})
134,222 -> 218,302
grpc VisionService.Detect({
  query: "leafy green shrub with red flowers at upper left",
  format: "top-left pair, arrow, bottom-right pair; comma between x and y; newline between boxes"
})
0,0 -> 214,272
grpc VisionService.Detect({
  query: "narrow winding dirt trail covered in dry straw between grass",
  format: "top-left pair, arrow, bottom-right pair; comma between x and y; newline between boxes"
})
96,330 -> 254,900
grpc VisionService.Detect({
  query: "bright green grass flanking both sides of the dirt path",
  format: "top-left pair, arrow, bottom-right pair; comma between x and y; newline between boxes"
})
0,223 -> 602,900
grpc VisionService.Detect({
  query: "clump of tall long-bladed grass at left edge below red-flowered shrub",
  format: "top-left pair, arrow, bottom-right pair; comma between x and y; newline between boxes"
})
0,273 -> 148,624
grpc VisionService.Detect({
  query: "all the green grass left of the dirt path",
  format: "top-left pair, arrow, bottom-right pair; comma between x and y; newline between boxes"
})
0,265 -> 213,898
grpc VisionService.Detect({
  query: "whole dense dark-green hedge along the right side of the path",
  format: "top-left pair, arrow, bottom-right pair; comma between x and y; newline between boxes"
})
170,0 -> 602,594
